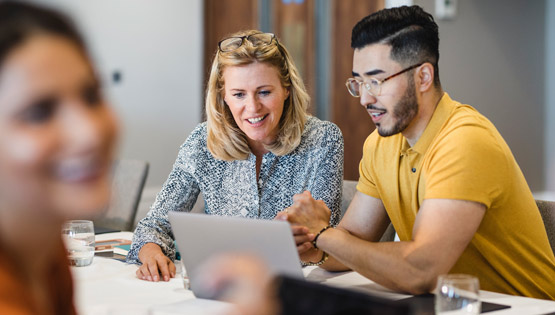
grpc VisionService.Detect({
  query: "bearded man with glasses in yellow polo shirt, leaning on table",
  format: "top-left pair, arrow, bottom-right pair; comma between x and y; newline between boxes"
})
279,6 -> 555,299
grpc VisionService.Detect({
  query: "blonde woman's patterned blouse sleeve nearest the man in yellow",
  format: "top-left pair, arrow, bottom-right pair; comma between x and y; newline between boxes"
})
308,122 -> 343,226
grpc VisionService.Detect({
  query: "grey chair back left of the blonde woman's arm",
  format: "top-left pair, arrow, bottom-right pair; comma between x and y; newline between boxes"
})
94,159 -> 149,231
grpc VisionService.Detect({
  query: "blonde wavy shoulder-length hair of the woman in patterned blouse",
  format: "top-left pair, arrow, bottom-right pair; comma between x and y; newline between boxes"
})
206,30 -> 310,161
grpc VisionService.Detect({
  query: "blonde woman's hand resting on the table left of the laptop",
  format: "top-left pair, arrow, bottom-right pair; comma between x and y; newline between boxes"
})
136,243 -> 175,282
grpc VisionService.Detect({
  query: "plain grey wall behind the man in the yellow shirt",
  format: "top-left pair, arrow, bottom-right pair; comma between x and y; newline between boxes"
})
420,0 -> 544,191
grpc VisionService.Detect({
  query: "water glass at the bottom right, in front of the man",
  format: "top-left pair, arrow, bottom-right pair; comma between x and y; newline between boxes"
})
435,274 -> 481,314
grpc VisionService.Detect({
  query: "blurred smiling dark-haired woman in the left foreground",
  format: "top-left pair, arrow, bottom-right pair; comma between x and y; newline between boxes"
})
0,2 -> 117,315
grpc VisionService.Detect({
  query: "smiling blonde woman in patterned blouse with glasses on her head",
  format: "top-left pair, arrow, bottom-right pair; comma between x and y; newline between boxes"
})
131,30 -> 343,281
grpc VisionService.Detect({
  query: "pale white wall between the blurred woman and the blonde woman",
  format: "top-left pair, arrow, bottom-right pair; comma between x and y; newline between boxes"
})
35,0 -> 203,190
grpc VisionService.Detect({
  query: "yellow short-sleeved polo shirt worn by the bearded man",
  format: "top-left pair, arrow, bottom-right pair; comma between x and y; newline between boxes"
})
357,93 -> 555,300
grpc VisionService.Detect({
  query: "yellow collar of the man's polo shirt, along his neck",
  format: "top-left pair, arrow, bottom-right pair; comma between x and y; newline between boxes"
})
412,93 -> 455,154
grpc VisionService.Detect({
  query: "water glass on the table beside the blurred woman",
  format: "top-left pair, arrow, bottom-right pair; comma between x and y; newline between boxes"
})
62,220 -> 94,267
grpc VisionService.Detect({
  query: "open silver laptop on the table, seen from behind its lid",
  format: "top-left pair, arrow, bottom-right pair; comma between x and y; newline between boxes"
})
169,212 -> 304,297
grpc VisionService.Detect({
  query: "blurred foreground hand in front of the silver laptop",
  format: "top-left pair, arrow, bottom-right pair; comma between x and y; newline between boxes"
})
196,254 -> 279,315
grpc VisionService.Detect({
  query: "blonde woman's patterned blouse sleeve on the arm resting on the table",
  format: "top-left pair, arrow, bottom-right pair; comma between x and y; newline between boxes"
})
127,132 -> 204,264
